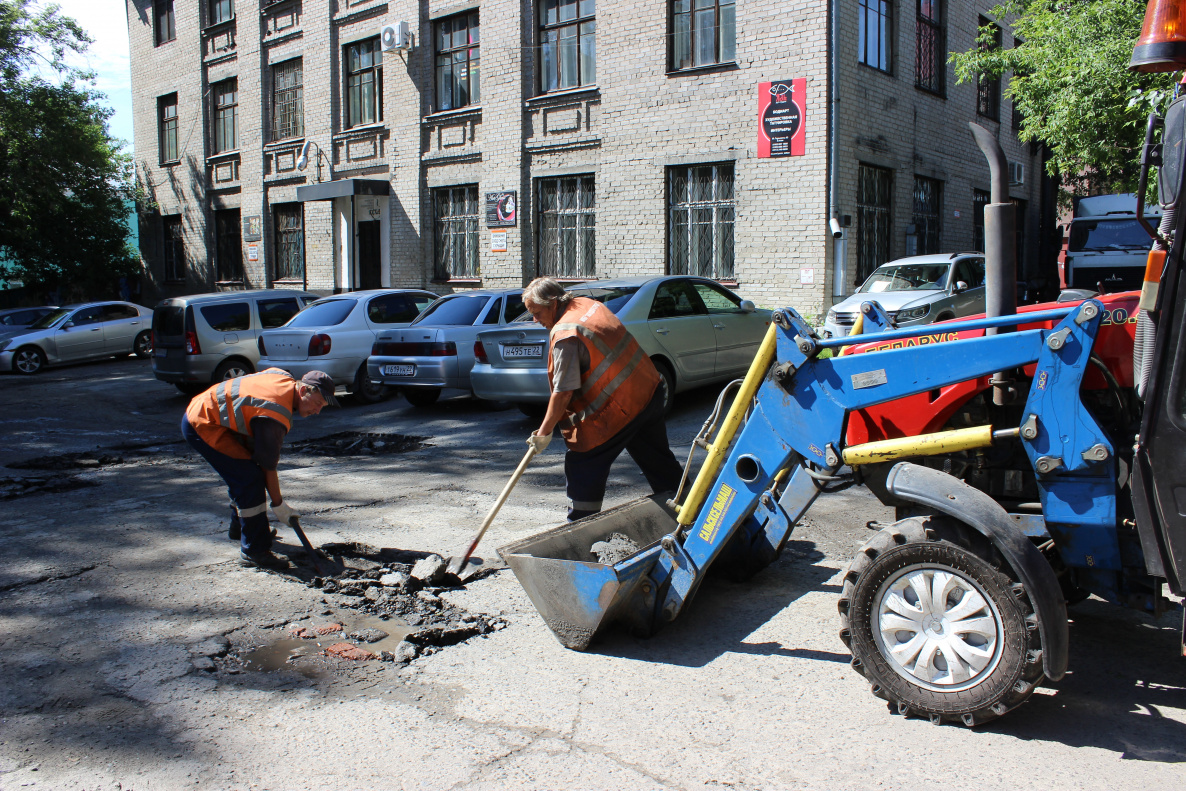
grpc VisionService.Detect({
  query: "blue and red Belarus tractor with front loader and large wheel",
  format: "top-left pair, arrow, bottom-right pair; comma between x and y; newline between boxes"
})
499,0 -> 1186,726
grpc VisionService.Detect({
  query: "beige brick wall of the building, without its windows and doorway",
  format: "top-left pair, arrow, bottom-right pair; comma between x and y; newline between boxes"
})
127,0 -> 1040,315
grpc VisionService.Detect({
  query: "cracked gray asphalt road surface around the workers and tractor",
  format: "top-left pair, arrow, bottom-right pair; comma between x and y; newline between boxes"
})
0,359 -> 1186,791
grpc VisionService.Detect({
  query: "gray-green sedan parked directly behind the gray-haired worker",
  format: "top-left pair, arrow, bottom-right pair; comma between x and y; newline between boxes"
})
470,275 -> 771,414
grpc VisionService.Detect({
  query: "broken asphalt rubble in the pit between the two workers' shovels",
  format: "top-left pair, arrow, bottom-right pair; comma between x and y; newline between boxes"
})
301,544 -> 506,664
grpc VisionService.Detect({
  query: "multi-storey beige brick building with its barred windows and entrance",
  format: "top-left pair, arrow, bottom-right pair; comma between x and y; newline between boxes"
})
127,0 -> 1053,315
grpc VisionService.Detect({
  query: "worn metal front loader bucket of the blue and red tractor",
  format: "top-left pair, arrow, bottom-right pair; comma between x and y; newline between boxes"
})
498,495 -> 677,651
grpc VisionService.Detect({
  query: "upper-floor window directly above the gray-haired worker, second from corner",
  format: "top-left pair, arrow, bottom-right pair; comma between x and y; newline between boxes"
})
540,0 -> 597,91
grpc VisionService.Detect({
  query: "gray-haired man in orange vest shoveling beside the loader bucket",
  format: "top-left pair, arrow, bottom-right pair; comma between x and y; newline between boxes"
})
523,278 -> 683,521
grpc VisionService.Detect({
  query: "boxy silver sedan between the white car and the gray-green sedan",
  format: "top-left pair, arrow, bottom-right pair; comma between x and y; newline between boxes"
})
366,288 -> 524,407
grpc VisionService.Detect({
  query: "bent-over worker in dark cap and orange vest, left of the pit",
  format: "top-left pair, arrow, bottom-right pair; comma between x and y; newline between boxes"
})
181,368 -> 338,569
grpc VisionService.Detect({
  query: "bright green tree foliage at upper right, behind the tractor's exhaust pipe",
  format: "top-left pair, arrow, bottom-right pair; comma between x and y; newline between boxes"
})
950,0 -> 1175,198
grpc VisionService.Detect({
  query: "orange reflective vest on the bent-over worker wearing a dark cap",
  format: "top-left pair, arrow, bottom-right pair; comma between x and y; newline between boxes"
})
185,368 -> 297,459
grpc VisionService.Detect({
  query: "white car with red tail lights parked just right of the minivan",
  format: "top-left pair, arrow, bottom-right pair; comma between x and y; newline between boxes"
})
259,288 -> 436,403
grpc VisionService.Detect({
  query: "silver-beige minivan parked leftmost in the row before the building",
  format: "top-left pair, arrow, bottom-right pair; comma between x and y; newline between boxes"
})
152,288 -> 317,394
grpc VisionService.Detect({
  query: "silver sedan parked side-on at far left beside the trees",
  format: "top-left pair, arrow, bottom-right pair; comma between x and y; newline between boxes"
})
0,302 -> 152,374
